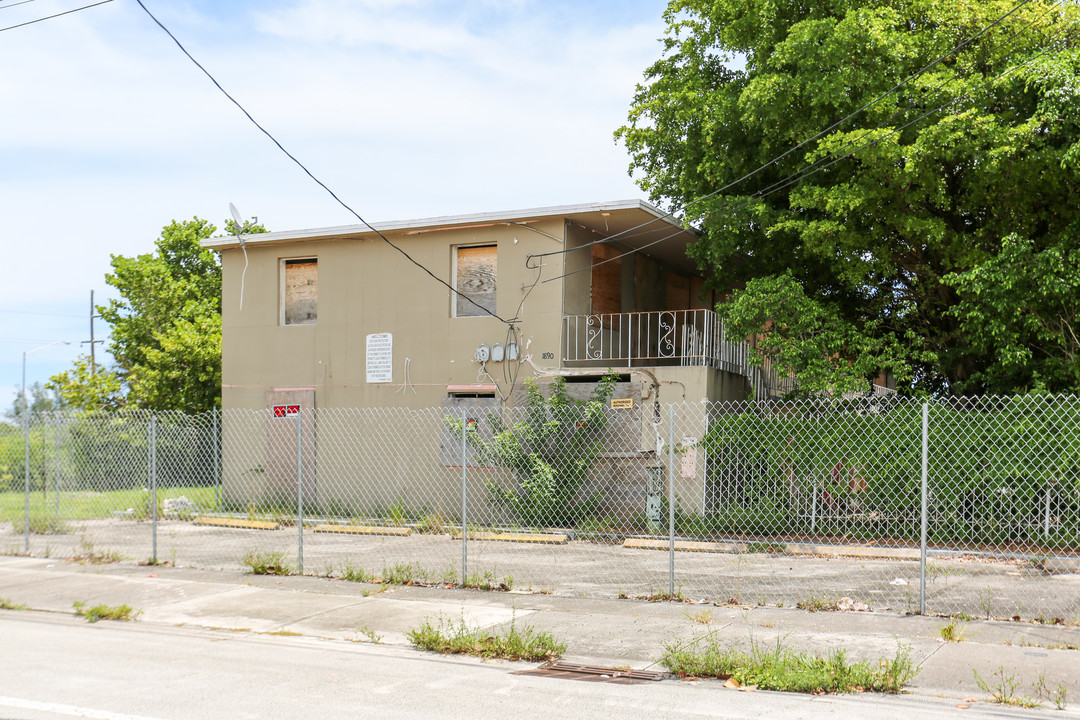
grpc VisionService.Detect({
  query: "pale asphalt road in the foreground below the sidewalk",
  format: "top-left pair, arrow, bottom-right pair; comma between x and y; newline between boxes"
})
0,612 -> 1054,720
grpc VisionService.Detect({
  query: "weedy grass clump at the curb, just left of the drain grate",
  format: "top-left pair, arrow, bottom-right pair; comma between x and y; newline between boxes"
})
406,620 -> 566,662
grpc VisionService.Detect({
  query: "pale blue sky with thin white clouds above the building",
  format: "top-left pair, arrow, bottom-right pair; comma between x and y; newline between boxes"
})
0,0 -> 666,407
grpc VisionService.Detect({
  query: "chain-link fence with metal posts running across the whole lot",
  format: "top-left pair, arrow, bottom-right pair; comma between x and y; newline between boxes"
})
0,397 -> 1080,623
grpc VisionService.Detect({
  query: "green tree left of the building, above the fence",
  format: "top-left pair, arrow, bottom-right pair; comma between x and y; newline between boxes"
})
50,217 -> 266,412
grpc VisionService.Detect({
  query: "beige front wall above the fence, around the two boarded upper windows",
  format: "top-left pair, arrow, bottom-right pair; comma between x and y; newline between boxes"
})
221,218 -> 570,408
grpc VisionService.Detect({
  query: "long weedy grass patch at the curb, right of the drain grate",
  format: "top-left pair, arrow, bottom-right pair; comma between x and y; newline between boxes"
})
659,640 -> 918,694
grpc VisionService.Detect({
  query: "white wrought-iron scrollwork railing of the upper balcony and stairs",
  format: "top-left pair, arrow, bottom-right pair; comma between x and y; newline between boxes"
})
563,310 -> 791,399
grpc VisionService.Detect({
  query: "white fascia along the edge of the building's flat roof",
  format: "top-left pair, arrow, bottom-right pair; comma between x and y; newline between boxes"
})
199,200 -> 693,249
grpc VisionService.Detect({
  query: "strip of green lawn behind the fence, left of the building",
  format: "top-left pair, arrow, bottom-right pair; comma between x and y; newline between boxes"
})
0,487 -> 216,521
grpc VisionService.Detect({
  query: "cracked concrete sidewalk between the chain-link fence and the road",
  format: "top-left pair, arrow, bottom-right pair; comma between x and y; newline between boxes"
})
0,556 -> 1080,717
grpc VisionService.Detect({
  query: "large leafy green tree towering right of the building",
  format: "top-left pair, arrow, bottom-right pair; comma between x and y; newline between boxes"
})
617,0 -> 1080,393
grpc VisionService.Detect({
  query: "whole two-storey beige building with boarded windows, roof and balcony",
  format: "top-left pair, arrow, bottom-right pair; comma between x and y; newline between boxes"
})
203,200 -> 786,514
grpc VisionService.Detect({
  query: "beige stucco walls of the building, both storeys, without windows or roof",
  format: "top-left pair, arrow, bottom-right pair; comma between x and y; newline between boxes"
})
209,205 -> 745,515
